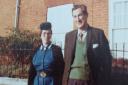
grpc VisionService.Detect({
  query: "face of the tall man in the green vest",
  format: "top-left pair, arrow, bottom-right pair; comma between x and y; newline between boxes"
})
73,8 -> 88,29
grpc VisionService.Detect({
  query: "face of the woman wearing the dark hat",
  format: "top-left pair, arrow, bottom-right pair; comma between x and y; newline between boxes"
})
41,30 -> 52,44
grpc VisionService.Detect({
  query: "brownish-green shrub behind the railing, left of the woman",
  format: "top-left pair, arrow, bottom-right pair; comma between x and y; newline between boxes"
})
0,31 -> 40,77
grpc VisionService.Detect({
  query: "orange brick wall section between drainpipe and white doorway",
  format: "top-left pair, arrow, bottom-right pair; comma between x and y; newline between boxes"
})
19,0 -> 47,31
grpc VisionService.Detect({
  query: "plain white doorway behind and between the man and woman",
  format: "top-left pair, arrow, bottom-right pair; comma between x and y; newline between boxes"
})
47,4 -> 73,51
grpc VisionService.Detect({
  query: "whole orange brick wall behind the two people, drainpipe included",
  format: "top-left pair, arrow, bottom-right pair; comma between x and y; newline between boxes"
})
0,0 -> 108,36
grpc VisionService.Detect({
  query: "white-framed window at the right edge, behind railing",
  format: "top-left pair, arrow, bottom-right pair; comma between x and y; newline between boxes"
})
109,0 -> 128,59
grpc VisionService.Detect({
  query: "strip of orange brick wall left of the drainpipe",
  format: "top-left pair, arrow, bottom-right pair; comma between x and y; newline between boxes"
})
0,0 -> 16,36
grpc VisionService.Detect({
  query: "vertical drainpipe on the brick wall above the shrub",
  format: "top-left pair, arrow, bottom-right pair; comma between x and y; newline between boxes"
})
14,0 -> 21,33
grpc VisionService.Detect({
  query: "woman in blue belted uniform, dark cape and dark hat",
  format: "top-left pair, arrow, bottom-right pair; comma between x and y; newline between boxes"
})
28,22 -> 64,85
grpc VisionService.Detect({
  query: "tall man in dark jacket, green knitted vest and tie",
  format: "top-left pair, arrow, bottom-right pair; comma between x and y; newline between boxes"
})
63,5 -> 112,85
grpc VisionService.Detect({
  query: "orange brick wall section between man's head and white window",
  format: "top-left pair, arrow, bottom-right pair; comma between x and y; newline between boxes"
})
92,0 -> 108,35
